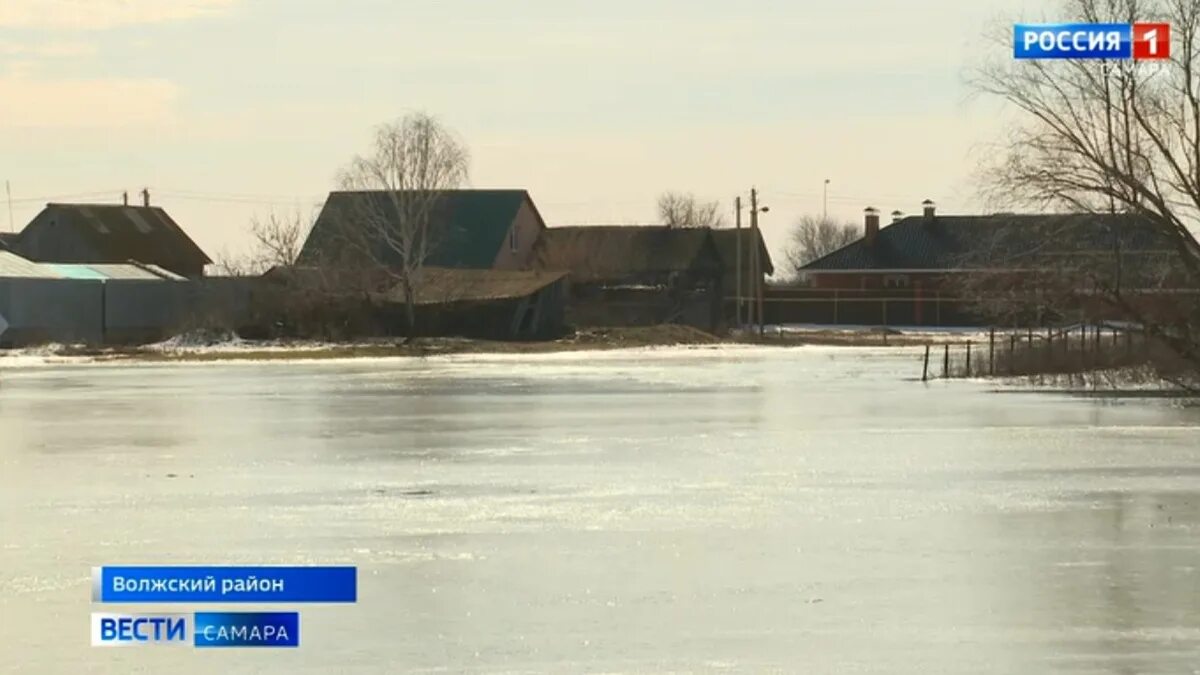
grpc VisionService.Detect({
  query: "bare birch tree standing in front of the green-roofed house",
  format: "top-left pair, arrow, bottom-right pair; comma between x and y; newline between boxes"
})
338,113 -> 469,338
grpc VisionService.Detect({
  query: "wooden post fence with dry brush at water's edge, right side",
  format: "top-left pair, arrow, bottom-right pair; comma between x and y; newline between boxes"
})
920,324 -> 1153,382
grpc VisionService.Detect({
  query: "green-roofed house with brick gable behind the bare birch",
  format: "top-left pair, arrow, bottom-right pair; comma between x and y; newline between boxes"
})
298,190 -> 546,269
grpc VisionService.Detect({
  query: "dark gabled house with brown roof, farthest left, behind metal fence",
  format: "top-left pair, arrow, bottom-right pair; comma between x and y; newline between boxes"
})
14,203 -> 212,279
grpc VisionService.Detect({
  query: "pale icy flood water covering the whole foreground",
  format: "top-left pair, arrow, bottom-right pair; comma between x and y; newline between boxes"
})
0,347 -> 1200,674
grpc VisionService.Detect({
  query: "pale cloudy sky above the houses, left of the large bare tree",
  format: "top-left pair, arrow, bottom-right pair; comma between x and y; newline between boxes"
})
0,0 -> 1052,265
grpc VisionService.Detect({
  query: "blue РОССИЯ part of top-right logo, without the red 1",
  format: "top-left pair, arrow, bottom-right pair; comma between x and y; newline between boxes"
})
1013,24 -> 1133,59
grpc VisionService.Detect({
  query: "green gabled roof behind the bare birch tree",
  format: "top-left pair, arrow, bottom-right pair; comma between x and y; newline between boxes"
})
299,190 -> 536,269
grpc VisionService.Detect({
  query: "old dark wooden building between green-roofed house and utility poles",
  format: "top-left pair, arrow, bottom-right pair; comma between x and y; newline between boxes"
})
533,226 -> 724,331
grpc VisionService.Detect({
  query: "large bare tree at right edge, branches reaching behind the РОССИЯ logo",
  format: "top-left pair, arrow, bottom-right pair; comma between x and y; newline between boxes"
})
974,0 -> 1200,379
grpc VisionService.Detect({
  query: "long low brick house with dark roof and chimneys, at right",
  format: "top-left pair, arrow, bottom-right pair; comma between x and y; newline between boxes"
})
787,201 -> 1178,325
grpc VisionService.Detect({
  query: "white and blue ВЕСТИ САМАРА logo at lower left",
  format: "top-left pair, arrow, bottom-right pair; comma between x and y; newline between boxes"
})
91,611 -> 300,647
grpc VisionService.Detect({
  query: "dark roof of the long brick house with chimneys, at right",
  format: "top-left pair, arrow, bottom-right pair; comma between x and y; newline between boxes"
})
802,214 -> 1171,271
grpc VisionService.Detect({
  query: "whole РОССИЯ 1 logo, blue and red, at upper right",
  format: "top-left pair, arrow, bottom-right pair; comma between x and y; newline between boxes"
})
1013,23 -> 1171,61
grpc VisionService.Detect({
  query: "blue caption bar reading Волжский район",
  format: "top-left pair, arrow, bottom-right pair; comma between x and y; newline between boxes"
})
91,566 -> 358,603
